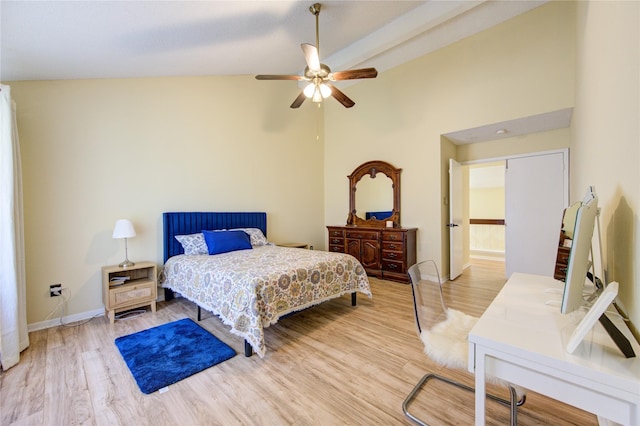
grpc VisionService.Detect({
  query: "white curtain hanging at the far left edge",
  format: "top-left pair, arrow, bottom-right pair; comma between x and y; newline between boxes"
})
0,85 -> 29,370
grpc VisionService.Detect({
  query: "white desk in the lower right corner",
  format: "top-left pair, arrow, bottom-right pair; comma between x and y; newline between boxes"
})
469,273 -> 640,426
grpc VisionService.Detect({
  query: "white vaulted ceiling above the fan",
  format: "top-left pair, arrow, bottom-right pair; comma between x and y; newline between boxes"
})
0,0 -> 547,81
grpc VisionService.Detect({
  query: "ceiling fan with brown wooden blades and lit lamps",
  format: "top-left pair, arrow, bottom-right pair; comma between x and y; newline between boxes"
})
256,3 -> 378,108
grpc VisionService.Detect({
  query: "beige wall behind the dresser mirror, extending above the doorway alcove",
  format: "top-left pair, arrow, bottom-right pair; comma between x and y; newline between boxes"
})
325,2 -> 575,274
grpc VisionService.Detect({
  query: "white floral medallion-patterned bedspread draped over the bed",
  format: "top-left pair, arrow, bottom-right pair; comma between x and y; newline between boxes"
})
162,245 -> 371,357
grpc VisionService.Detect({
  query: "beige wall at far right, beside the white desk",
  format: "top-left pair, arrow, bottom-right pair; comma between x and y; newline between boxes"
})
570,1 -> 640,337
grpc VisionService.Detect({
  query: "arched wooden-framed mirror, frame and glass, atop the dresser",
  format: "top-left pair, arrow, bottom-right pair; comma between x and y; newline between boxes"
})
347,161 -> 402,227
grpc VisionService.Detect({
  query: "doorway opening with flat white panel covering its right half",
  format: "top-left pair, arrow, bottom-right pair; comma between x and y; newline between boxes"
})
450,150 -> 569,276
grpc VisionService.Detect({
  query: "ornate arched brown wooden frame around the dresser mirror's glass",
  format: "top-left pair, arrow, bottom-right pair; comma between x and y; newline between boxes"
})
347,161 -> 402,227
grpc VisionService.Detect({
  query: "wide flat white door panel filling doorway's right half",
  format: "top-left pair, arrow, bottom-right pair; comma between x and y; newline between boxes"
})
505,152 -> 568,277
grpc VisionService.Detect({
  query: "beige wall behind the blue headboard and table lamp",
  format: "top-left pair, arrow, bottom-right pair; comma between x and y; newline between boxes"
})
9,76 -> 326,325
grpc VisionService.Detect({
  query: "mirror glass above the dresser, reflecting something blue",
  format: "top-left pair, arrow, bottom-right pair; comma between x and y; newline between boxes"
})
356,173 -> 393,220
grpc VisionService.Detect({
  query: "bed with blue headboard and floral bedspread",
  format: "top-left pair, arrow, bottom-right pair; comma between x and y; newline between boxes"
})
160,212 -> 371,358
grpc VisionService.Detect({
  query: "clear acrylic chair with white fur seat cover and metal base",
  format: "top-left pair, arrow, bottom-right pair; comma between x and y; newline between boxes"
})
402,260 -> 526,426
